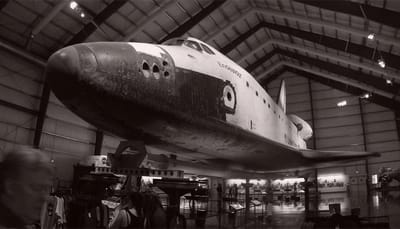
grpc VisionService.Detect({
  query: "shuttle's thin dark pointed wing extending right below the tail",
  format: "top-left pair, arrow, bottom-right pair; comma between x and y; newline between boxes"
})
300,149 -> 379,162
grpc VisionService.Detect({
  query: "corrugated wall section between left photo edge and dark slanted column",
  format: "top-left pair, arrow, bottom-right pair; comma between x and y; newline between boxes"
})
0,49 -> 43,157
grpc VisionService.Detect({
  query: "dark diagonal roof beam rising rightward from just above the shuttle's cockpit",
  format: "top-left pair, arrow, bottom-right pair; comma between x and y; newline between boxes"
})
158,0 -> 226,43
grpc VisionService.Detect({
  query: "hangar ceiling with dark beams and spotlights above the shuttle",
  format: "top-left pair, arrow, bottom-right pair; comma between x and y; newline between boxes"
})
0,0 -> 400,112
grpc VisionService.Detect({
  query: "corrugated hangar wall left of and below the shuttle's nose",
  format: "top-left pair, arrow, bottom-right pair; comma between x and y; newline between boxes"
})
0,49 -> 123,182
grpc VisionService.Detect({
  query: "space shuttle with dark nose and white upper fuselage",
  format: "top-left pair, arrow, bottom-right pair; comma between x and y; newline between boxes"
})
46,37 -> 376,177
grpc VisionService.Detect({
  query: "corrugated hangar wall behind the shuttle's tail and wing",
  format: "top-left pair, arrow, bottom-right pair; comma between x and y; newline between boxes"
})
267,72 -> 400,184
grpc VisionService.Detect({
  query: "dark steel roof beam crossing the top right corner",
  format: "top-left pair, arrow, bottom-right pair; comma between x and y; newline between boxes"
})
294,0 -> 400,28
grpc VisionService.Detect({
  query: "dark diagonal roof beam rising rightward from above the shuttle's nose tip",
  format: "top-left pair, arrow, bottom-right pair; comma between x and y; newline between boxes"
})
66,0 -> 129,46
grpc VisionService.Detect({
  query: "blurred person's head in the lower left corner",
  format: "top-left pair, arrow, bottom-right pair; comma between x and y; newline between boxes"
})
0,146 -> 53,228
